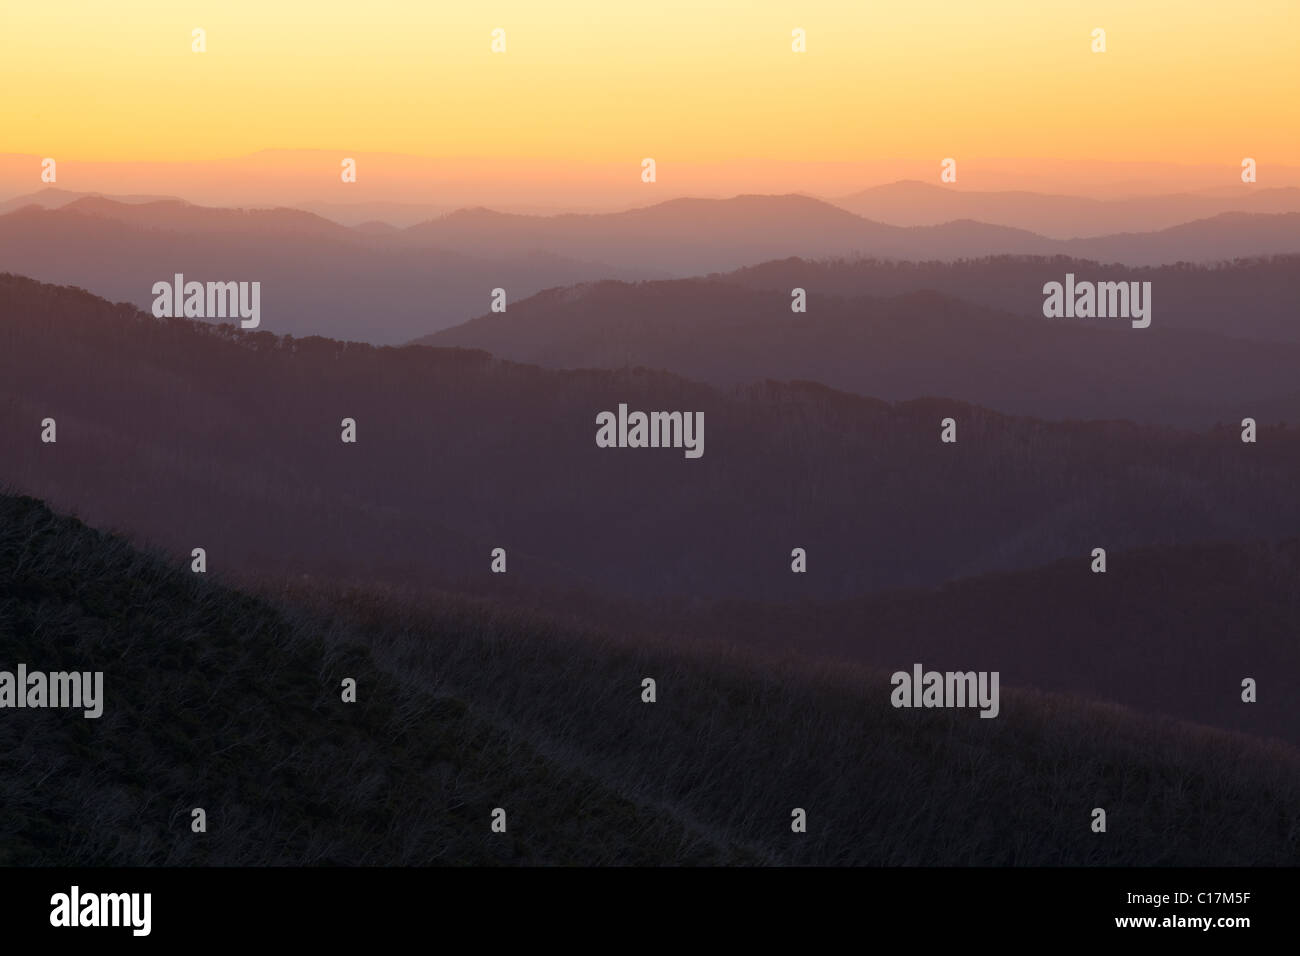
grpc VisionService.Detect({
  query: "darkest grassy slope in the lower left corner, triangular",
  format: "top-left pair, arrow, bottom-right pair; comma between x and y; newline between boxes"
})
0,497 -> 741,865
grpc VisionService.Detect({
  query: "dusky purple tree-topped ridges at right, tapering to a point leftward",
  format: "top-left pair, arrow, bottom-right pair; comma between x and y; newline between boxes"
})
417,259 -> 1300,427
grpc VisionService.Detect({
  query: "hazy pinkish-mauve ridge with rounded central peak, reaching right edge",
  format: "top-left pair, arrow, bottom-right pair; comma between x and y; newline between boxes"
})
403,195 -> 1300,276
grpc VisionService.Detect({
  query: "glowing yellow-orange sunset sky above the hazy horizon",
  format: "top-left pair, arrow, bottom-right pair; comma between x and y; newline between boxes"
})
0,0 -> 1300,204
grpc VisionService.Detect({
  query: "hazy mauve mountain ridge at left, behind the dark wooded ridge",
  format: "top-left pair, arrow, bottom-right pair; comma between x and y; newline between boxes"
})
0,198 -> 662,343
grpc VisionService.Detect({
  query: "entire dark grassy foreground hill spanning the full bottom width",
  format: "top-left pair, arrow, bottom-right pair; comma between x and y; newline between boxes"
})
0,497 -> 1300,865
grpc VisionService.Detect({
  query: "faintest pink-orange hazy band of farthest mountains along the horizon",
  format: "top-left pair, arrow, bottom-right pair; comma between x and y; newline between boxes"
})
0,144 -> 1300,213
